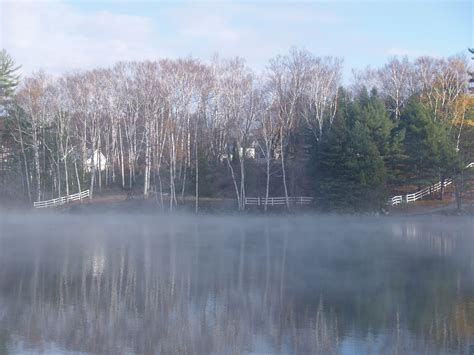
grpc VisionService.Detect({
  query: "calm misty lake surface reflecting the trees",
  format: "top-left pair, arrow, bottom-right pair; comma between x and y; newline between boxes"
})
0,213 -> 474,354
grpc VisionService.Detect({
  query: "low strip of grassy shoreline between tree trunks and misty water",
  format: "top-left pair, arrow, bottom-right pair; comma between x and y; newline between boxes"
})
0,190 -> 474,217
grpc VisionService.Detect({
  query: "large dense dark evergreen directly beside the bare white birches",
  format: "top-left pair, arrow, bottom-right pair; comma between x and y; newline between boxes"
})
313,90 -> 391,210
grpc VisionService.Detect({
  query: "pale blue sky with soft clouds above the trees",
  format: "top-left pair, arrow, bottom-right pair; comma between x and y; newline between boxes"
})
0,0 -> 473,80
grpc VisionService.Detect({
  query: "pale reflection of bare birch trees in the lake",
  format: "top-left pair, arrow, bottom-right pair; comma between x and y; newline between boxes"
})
0,217 -> 335,353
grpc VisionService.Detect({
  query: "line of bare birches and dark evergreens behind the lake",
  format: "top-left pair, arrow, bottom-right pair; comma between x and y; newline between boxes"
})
0,48 -> 473,211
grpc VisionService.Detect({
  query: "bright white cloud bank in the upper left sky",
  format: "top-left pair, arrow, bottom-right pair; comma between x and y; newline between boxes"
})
0,2 -> 165,74
